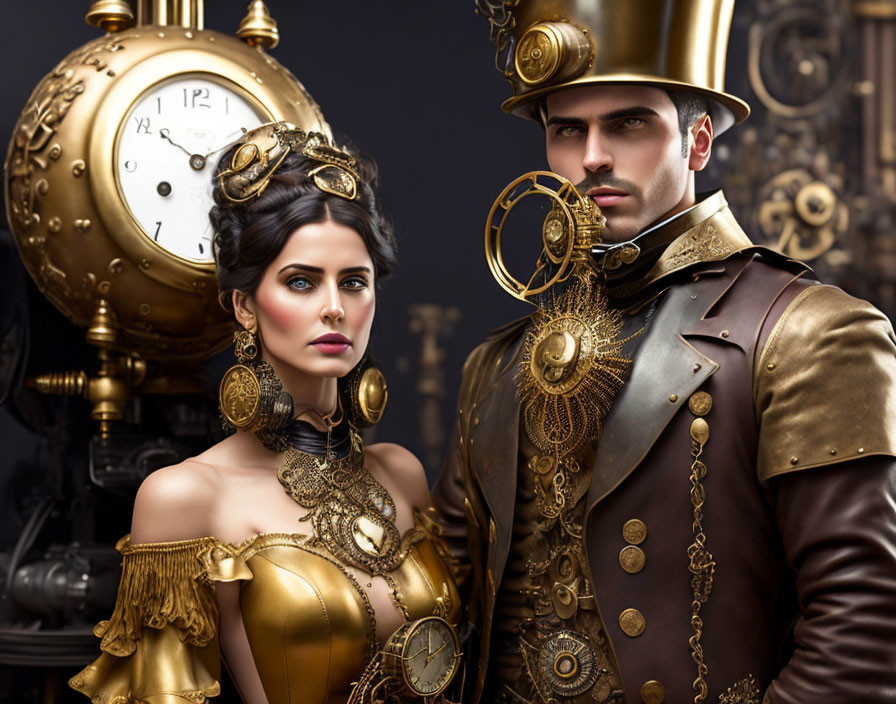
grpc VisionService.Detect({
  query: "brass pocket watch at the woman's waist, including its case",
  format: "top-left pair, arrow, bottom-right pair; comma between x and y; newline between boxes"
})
383,616 -> 461,697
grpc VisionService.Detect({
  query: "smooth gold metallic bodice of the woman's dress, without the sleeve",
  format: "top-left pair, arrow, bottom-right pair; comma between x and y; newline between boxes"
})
240,535 -> 459,704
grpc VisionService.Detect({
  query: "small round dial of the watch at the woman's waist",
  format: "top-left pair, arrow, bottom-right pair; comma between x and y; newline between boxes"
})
402,616 -> 459,696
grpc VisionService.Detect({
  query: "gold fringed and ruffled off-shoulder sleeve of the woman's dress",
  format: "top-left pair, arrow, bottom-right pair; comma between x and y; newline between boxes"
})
69,536 -> 252,704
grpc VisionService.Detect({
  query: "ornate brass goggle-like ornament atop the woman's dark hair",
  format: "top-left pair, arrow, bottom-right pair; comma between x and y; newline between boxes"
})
217,122 -> 361,203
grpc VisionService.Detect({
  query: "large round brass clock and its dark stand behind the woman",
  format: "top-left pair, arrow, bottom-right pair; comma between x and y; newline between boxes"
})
0,0 -> 330,701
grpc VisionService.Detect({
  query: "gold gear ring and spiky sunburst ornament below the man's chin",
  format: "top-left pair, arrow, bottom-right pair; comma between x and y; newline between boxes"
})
485,171 -> 631,519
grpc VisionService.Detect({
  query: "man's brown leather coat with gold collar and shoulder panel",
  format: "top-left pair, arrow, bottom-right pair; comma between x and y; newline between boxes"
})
434,195 -> 896,704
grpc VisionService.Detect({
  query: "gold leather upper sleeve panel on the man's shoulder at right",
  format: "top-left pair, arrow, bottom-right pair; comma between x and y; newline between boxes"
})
754,285 -> 896,481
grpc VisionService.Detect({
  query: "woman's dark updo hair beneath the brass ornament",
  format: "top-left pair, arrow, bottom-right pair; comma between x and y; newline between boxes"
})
209,144 -> 397,311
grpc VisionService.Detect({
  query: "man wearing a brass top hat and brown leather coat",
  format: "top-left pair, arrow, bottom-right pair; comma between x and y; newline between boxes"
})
434,0 -> 896,704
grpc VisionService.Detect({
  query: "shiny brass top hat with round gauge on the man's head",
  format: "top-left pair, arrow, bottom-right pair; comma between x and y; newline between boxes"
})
477,0 -> 750,134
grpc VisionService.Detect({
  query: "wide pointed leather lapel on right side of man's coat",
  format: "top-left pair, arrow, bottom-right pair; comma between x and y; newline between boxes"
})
586,264 -> 745,511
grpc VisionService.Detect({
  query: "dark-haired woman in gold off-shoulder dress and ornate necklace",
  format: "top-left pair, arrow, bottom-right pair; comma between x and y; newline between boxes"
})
71,123 -> 459,704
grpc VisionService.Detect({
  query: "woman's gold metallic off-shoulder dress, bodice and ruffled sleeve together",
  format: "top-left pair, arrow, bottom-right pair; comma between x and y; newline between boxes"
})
70,519 -> 459,704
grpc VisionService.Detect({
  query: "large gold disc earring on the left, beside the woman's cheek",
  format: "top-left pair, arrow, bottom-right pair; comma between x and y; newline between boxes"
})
218,328 -> 293,445
